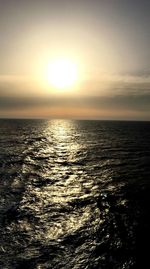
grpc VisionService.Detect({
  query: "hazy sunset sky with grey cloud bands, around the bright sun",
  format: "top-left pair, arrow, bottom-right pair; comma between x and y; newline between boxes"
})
0,0 -> 150,120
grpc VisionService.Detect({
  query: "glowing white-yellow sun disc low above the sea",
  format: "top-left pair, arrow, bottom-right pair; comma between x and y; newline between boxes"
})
47,59 -> 78,90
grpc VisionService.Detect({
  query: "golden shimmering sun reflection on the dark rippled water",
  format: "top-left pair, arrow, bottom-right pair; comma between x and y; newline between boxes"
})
21,120 -> 99,240
